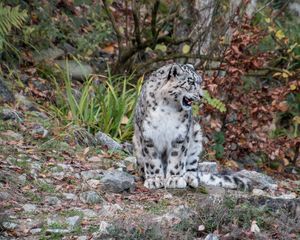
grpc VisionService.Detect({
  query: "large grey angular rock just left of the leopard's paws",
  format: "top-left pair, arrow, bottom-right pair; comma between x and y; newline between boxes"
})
100,171 -> 135,193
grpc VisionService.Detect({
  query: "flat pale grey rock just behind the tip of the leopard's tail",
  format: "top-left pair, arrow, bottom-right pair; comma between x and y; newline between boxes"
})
237,170 -> 277,190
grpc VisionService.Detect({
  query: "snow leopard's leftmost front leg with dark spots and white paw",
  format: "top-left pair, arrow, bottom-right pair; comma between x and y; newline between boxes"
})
142,139 -> 164,189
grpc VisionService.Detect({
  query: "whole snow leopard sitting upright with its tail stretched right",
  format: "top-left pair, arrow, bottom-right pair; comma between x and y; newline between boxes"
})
133,63 -> 249,189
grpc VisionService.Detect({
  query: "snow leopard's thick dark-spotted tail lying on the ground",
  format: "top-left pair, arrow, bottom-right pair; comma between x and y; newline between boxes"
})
198,172 -> 253,191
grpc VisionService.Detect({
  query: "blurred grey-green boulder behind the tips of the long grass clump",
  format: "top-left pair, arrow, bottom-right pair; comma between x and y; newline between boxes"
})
55,60 -> 93,80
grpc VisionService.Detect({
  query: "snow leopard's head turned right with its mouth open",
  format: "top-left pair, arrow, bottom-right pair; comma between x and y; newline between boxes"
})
162,64 -> 203,111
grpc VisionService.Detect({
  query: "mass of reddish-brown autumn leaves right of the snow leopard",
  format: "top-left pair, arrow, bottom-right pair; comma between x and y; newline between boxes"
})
201,17 -> 300,171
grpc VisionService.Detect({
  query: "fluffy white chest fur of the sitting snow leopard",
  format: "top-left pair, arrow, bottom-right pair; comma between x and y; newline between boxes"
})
142,105 -> 191,151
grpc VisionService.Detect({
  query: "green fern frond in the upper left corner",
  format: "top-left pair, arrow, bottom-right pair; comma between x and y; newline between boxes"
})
0,3 -> 27,51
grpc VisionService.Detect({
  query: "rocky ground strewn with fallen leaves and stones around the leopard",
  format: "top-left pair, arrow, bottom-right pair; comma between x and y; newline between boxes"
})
0,106 -> 300,240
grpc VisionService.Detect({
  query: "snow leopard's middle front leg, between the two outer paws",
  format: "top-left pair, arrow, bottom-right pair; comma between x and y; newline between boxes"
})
165,140 -> 187,188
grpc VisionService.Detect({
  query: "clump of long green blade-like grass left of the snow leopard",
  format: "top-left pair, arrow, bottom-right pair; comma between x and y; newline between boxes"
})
52,62 -> 143,140
